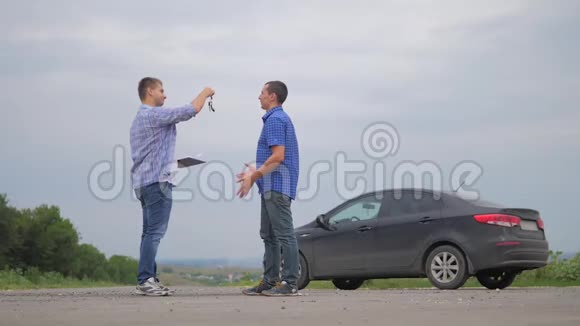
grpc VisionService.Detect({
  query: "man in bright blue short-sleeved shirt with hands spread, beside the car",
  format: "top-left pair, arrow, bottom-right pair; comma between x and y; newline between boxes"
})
238,81 -> 299,296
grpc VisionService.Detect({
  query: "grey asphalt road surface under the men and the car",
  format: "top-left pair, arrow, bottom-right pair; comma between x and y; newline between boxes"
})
0,287 -> 580,326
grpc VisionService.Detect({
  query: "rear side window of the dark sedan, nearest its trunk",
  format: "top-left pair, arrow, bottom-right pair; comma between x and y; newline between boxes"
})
388,191 -> 442,216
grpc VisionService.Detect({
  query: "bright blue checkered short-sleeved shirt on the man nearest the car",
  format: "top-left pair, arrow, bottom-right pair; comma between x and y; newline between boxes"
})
256,106 -> 299,199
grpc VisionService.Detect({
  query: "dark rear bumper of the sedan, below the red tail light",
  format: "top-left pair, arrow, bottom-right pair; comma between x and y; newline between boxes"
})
469,240 -> 550,273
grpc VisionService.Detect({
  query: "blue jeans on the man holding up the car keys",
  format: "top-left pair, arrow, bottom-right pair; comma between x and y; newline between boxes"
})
135,182 -> 173,284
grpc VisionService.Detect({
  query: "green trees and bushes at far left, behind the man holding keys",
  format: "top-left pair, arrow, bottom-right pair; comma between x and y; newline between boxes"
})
0,194 -> 138,284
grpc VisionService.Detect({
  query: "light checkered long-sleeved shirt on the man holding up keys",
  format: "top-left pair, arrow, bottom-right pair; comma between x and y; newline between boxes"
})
130,104 -> 196,189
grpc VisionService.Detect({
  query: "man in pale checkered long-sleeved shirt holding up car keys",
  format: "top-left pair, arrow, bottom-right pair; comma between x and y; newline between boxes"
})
130,77 -> 214,296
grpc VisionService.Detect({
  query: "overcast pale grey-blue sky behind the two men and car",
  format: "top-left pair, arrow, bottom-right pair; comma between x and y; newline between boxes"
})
0,0 -> 580,259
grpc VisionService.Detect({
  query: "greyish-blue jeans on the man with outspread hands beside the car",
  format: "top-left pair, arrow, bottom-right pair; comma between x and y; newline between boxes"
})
260,191 -> 299,288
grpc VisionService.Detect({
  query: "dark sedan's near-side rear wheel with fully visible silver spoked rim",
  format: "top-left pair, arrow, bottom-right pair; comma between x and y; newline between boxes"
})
425,245 -> 469,290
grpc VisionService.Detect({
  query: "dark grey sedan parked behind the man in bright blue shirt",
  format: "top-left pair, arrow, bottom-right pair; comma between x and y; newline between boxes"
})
295,189 -> 548,290
